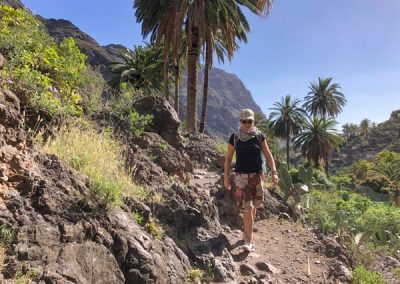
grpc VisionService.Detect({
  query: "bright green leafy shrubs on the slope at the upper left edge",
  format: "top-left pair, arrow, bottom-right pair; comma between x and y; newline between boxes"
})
0,6 -> 87,116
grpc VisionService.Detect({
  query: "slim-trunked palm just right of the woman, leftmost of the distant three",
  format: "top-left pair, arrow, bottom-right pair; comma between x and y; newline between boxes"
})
269,95 -> 307,167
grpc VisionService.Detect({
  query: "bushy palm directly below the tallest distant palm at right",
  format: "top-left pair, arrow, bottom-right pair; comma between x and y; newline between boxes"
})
294,116 -> 344,173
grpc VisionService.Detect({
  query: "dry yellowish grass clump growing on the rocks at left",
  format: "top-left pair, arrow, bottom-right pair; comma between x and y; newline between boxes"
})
41,120 -> 137,208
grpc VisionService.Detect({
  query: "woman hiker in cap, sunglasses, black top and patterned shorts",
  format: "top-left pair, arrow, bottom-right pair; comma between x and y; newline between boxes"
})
224,109 -> 279,251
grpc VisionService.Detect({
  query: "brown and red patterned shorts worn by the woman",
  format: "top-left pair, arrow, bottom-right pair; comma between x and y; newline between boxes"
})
236,173 -> 264,212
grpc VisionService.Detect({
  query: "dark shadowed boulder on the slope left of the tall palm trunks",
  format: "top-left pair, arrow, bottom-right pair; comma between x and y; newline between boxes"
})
132,96 -> 183,150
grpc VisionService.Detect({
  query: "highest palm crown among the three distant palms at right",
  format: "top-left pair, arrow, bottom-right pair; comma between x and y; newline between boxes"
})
303,78 -> 347,117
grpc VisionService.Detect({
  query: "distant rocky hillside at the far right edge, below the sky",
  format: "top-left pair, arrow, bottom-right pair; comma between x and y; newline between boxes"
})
332,110 -> 400,169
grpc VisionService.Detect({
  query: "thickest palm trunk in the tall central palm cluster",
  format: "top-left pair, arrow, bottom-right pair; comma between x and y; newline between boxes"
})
186,24 -> 200,132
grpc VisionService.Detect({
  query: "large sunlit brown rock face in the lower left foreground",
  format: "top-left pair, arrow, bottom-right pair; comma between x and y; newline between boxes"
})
0,87 -> 190,284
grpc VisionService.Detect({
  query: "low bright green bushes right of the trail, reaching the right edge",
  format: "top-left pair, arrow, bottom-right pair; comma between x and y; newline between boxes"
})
304,190 -> 400,240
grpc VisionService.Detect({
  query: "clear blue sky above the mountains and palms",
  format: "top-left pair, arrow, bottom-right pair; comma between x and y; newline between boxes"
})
23,0 -> 400,124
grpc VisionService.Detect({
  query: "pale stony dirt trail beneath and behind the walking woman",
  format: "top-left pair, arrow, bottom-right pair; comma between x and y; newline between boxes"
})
191,169 -> 340,284
